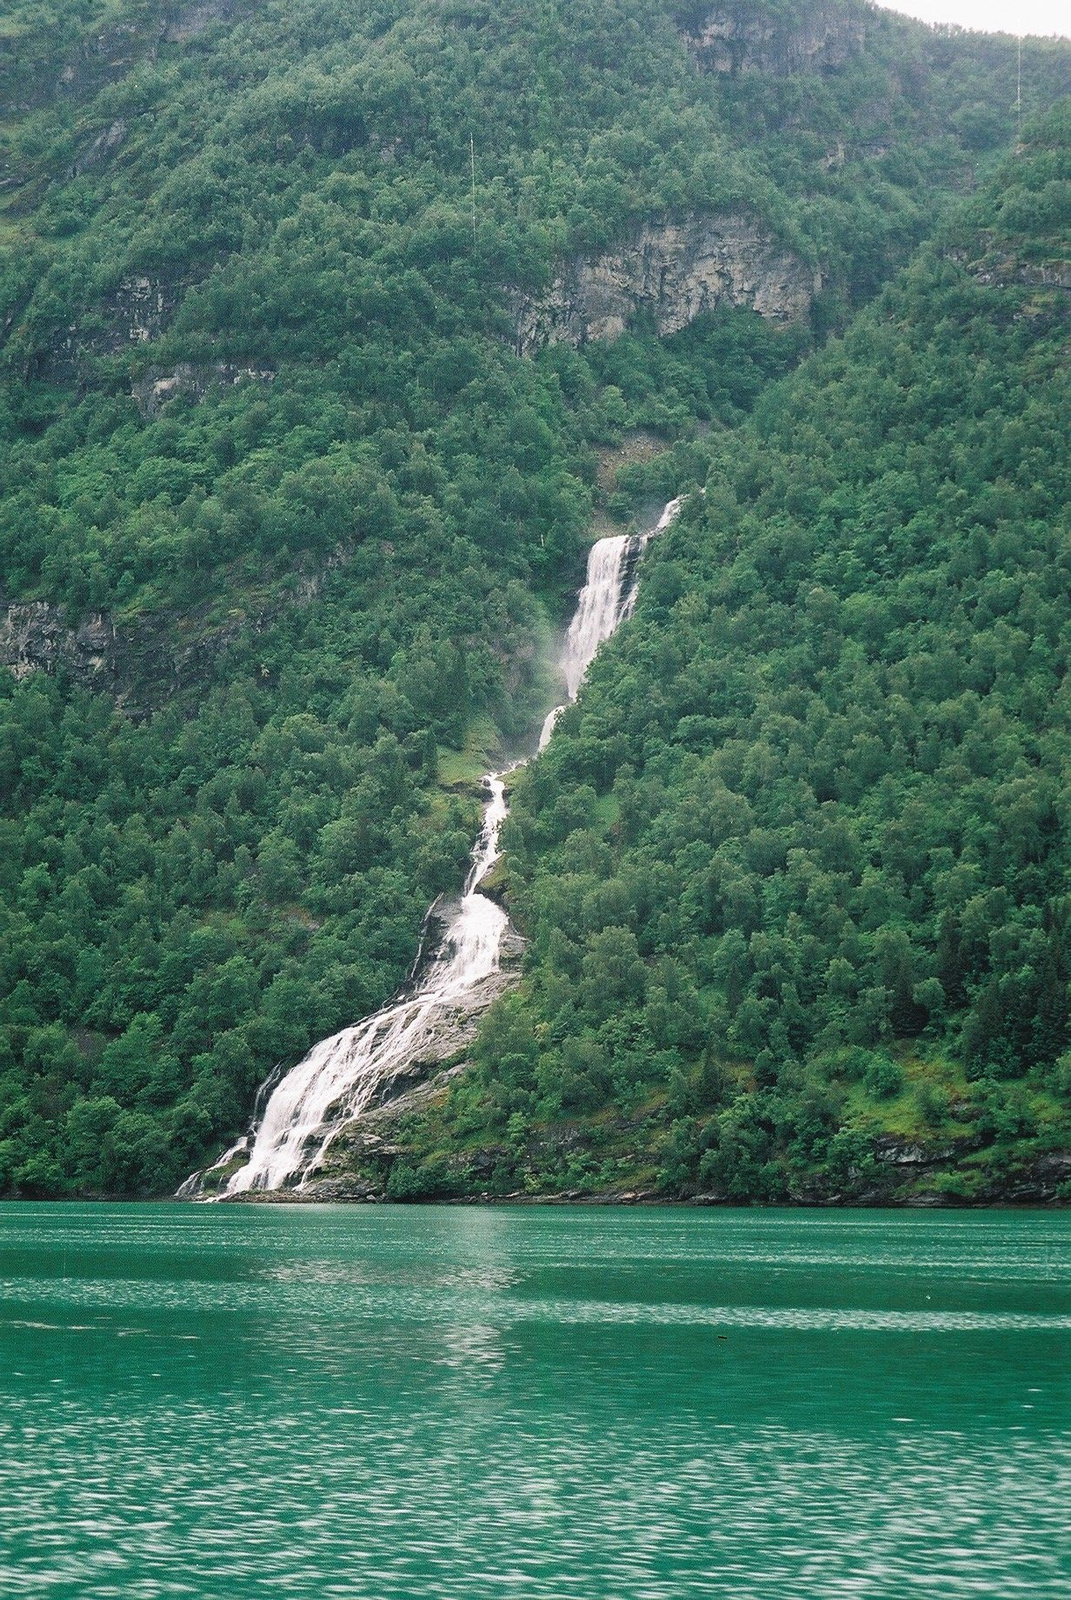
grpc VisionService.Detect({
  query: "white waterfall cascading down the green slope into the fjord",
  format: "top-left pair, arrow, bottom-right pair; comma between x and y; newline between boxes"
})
178,499 -> 680,1200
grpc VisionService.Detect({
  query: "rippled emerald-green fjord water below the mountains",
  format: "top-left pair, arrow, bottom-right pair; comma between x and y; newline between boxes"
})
0,1205 -> 1071,1600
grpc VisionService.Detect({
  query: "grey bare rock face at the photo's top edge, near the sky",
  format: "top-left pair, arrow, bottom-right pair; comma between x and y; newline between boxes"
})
684,0 -> 866,77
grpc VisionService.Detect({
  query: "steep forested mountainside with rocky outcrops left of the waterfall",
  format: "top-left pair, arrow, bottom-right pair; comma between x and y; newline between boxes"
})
0,0 -> 1068,1195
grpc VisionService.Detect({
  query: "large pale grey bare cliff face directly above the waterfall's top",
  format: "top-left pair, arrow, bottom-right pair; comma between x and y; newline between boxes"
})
514,216 -> 821,355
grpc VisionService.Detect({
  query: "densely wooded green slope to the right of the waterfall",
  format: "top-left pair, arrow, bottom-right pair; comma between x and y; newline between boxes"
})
379,102 -> 1071,1200
